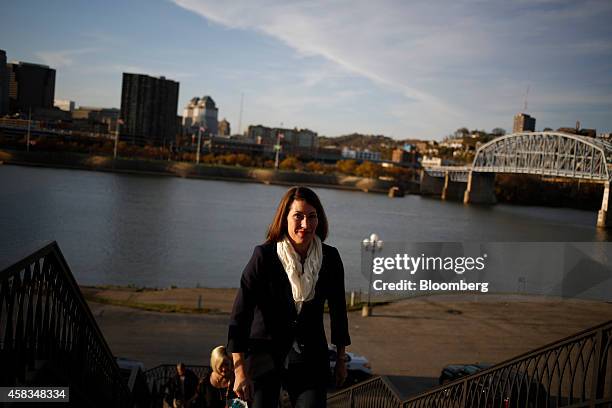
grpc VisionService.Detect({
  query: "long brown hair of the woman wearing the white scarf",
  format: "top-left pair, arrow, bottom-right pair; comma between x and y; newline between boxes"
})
266,187 -> 328,242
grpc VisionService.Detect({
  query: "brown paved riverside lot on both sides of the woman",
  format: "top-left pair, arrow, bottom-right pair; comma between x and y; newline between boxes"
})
90,296 -> 612,378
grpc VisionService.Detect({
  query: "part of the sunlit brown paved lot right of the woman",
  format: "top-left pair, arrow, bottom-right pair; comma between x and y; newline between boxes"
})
340,297 -> 612,378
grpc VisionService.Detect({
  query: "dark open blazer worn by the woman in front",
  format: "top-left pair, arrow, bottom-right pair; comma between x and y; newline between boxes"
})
228,243 -> 351,369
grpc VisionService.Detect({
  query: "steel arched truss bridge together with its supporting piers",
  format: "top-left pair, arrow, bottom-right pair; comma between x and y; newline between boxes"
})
421,132 -> 612,228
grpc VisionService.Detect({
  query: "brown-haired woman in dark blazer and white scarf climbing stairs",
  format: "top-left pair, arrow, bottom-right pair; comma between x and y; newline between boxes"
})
228,187 -> 350,408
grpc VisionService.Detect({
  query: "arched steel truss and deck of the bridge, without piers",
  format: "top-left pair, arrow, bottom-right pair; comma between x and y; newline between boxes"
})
425,132 -> 612,182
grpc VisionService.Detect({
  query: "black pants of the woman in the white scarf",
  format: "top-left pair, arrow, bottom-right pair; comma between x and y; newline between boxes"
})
252,356 -> 328,408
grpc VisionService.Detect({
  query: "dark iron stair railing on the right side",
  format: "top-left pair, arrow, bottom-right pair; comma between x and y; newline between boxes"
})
328,321 -> 612,408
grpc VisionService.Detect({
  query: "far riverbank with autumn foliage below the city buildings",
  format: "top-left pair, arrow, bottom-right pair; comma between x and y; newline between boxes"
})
0,149 -> 418,194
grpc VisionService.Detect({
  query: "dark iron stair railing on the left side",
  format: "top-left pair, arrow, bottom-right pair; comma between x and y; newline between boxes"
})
0,241 -> 132,407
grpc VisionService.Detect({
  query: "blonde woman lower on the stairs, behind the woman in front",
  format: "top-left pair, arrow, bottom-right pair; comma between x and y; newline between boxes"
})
196,346 -> 236,408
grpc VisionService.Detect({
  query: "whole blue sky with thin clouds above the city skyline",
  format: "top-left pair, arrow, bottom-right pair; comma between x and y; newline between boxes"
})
0,0 -> 612,140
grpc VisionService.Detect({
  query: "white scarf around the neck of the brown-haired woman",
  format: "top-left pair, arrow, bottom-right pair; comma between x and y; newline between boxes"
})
276,235 -> 323,314
